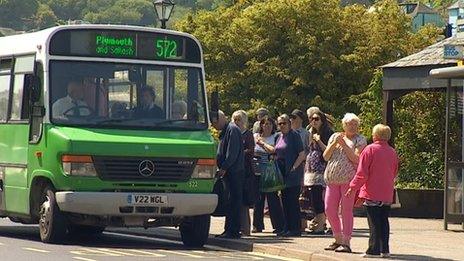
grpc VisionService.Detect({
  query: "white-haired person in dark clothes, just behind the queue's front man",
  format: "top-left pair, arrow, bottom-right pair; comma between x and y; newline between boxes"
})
232,110 -> 257,236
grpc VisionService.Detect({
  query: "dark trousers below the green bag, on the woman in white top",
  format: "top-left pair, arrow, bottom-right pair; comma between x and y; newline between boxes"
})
253,188 -> 284,231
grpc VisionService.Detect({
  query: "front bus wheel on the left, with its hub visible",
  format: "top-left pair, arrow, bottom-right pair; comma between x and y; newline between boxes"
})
39,186 -> 67,243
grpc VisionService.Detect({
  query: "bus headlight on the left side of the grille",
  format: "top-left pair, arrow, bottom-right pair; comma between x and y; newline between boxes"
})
61,155 -> 97,177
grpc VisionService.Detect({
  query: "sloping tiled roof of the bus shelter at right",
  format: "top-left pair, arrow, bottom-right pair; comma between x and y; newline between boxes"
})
382,34 -> 464,68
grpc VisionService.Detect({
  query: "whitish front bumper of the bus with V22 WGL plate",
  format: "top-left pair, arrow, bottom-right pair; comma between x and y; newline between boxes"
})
55,191 -> 218,217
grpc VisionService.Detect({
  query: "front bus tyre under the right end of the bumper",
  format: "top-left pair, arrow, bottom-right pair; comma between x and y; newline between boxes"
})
179,215 -> 211,247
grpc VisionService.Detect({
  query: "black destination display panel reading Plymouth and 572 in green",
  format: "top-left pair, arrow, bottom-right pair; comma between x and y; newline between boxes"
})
50,29 -> 201,63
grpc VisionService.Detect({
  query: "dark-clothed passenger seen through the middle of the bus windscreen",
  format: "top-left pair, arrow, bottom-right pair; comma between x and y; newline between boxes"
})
134,85 -> 164,119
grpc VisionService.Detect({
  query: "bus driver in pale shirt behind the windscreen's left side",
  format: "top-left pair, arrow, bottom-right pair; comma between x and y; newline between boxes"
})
52,80 -> 92,119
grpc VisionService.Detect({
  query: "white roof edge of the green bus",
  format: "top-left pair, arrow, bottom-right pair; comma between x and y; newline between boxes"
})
0,24 -> 201,57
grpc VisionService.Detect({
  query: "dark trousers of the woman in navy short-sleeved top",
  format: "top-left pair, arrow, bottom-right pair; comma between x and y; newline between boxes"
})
282,186 -> 301,233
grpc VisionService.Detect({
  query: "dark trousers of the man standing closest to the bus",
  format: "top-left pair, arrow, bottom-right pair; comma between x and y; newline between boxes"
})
224,171 -> 245,236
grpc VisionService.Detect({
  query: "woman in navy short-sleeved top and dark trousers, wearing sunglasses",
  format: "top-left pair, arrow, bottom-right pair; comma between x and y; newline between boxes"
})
275,114 -> 306,237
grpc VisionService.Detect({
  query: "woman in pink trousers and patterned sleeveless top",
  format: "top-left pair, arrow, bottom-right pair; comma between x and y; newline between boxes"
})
323,113 -> 367,253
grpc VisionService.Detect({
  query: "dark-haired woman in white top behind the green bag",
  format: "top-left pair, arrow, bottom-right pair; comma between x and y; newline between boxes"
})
252,117 -> 284,233
